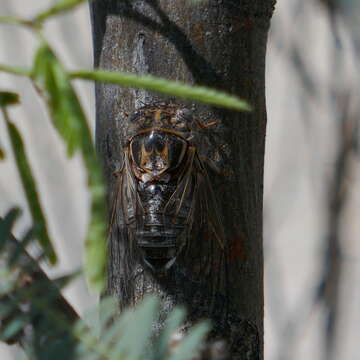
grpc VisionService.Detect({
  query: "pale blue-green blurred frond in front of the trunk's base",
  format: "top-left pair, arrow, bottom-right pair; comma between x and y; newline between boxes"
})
74,296 -> 209,360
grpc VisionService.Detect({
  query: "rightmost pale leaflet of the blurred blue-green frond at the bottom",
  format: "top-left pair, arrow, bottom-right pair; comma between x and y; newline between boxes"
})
169,322 -> 210,360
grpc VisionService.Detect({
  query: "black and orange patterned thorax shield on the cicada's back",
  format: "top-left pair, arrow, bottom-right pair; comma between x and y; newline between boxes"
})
130,130 -> 187,175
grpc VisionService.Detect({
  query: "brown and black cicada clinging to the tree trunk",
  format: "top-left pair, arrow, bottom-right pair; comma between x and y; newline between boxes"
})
111,104 -> 225,272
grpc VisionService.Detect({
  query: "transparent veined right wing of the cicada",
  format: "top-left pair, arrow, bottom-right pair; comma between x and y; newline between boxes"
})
166,147 -> 225,278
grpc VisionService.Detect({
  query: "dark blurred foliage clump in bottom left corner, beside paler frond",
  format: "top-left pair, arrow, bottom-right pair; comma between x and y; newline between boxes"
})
0,209 -> 78,360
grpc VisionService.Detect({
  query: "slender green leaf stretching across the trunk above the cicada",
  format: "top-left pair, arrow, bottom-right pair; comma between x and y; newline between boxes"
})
71,70 -> 251,111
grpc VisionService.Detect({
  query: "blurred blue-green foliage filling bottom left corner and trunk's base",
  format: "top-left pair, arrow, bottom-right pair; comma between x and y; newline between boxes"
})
0,209 -> 209,360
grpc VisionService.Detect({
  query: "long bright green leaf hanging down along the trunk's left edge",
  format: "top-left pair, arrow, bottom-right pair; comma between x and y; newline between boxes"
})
32,44 -> 106,291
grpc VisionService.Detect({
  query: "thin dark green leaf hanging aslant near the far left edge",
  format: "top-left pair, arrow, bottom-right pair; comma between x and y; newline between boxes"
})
4,119 -> 57,264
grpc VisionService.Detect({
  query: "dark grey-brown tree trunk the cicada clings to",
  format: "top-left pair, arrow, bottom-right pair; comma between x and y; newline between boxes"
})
91,0 -> 275,359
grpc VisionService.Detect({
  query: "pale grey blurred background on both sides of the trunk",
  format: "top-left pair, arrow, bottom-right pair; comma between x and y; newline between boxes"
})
0,0 -> 360,360
